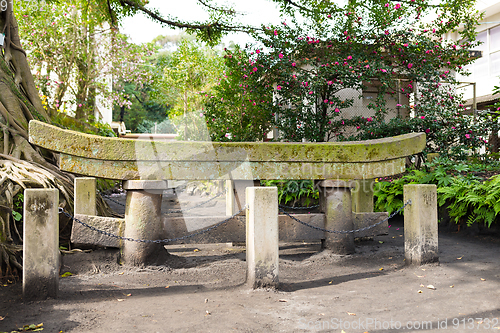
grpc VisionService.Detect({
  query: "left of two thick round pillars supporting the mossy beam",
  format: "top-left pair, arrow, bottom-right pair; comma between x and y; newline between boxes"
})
122,180 -> 168,266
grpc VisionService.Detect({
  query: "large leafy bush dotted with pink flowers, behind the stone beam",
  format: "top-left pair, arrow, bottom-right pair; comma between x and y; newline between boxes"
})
202,0 -> 492,160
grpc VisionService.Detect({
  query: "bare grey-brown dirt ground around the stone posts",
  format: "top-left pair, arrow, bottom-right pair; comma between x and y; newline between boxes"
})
0,191 -> 500,333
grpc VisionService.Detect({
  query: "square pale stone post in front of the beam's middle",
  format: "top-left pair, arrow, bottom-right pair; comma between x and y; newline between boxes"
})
246,187 -> 279,288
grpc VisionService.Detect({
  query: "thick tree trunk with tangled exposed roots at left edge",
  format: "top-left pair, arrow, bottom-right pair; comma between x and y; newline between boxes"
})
0,6 -> 109,279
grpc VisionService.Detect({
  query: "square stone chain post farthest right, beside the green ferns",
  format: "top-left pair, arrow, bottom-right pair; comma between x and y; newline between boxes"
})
403,184 -> 439,265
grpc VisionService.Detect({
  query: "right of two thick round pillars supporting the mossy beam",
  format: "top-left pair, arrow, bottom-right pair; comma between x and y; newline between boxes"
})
318,180 -> 355,254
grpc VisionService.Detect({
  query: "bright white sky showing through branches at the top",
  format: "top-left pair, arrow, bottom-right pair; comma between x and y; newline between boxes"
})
120,0 -> 280,45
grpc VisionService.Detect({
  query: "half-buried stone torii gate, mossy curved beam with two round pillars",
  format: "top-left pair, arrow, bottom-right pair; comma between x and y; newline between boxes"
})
25,121 -> 432,296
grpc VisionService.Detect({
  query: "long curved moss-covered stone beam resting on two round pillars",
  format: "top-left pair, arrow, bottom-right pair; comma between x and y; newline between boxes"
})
29,121 -> 425,180
